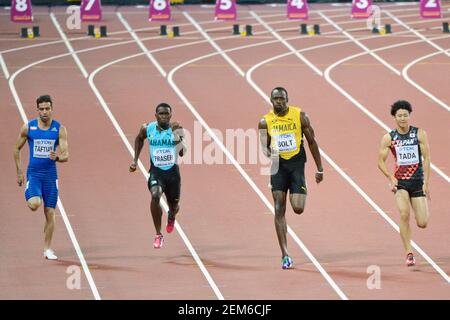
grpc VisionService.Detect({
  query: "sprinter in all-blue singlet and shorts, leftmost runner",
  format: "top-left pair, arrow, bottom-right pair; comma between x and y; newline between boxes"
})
14,95 -> 69,260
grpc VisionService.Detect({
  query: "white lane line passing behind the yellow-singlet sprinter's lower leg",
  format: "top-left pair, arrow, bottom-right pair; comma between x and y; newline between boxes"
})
168,12 -> 348,300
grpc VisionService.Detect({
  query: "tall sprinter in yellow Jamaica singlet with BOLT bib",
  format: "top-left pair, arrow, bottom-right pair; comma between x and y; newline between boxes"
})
258,87 -> 323,269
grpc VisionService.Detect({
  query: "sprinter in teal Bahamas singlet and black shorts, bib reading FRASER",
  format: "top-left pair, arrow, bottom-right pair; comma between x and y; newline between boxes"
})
129,103 -> 186,249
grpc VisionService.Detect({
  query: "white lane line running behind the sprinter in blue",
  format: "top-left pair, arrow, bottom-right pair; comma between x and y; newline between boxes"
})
8,73 -> 101,300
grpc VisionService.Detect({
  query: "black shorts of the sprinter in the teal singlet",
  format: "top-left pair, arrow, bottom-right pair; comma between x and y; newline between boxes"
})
148,165 -> 181,203
